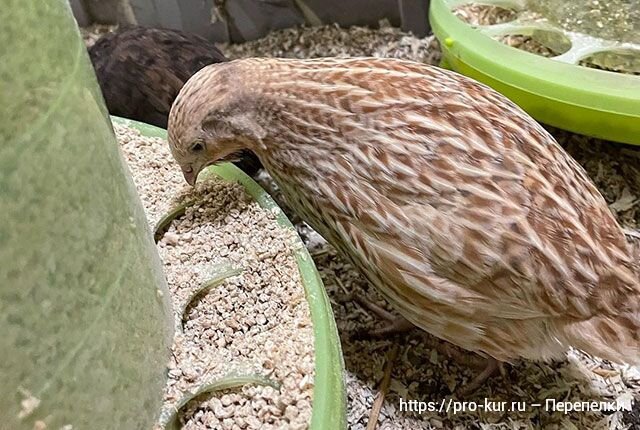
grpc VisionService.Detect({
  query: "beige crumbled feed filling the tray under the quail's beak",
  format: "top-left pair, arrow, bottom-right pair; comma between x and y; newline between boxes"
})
115,122 -> 314,429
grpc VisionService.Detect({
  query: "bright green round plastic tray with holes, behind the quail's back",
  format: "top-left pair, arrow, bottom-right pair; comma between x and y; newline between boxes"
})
429,0 -> 640,145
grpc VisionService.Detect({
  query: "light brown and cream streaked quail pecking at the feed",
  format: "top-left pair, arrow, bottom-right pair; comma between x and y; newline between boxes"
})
169,58 -> 640,363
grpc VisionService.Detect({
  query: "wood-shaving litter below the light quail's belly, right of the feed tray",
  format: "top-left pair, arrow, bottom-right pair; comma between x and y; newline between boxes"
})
315,245 -> 640,429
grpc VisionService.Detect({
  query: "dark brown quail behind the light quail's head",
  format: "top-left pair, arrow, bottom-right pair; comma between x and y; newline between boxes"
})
89,27 -> 260,175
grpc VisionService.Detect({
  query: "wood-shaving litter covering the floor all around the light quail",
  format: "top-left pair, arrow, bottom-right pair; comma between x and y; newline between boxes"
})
226,26 -> 640,430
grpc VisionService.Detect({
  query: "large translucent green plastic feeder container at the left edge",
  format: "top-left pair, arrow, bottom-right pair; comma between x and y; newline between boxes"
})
0,0 -> 173,430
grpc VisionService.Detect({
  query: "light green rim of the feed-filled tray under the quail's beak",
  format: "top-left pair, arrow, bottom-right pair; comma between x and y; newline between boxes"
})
112,117 -> 346,430
